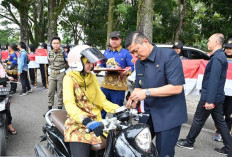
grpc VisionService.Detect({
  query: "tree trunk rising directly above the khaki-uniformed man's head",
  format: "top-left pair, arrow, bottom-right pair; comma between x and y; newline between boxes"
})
48,0 -> 57,42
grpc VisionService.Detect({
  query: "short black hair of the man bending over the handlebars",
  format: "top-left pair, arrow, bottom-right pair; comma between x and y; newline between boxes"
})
125,31 -> 150,48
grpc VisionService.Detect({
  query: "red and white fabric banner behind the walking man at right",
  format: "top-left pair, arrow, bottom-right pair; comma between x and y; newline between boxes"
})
182,59 -> 232,96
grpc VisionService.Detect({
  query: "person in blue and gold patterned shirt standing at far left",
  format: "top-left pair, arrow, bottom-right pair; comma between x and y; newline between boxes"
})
6,44 -> 18,94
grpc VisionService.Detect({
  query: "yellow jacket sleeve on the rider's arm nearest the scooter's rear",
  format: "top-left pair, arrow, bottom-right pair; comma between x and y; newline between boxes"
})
63,75 -> 87,123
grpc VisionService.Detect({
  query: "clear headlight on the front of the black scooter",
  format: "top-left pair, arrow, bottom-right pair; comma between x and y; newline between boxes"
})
135,128 -> 152,152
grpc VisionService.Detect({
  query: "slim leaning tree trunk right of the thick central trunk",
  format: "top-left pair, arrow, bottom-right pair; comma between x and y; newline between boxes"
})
174,0 -> 188,41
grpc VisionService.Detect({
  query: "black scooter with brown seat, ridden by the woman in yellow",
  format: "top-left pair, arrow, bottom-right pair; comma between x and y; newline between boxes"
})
35,106 -> 158,157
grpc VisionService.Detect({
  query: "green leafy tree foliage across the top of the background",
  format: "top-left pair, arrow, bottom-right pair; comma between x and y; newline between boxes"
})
0,0 -> 232,50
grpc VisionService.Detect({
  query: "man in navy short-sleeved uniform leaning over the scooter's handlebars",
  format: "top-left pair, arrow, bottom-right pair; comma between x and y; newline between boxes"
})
125,32 -> 187,157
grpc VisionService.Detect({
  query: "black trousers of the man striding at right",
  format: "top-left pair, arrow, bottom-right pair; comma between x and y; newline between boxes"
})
186,100 -> 232,149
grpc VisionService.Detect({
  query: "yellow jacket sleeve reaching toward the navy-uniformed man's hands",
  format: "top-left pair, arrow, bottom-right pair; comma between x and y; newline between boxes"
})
94,76 -> 120,113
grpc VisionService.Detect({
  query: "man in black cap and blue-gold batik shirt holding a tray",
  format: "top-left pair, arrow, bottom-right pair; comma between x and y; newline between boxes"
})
100,31 -> 134,118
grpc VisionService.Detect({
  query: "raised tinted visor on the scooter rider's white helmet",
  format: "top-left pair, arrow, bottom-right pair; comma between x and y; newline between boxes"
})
81,47 -> 107,63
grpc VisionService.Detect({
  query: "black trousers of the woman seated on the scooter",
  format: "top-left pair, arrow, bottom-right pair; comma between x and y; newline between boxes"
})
69,142 -> 91,157
